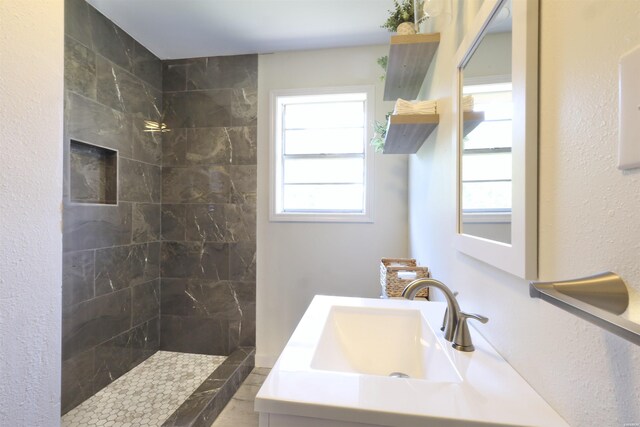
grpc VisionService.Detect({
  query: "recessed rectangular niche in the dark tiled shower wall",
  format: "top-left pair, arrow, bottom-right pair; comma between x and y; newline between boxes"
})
69,139 -> 118,205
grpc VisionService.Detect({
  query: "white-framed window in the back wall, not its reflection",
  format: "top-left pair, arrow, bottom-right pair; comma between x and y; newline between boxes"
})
270,86 -> 374,222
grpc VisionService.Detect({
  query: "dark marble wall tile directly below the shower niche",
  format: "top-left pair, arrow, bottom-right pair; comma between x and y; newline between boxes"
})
62,202 -> 132,252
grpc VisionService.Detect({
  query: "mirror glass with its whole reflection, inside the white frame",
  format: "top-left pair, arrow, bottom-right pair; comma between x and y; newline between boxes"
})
460,1 -> 513,244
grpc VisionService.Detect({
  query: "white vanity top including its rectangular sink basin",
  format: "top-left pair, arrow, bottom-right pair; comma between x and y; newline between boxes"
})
255,296 -> 568,427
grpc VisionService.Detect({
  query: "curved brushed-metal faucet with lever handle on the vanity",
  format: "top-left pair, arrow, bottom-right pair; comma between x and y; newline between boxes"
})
402,278 -> 489,351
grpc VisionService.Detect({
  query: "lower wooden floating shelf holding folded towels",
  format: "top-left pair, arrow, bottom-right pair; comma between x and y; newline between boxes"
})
382,114 -> 440,154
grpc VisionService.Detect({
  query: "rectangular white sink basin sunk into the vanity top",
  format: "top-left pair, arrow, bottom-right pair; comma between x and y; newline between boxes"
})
311,306 -> 462,382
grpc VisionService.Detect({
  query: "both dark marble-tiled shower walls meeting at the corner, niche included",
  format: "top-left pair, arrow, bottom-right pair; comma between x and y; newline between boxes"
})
62,0 -> 257,422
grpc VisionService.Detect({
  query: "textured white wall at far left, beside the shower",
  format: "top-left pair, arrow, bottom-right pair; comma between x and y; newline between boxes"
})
0,0 -> 64,427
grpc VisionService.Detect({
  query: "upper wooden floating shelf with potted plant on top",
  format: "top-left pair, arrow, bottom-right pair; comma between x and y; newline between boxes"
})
384,33 -> 440,101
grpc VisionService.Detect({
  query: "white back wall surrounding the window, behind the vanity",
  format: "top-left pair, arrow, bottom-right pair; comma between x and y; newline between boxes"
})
256,46 -> 407,366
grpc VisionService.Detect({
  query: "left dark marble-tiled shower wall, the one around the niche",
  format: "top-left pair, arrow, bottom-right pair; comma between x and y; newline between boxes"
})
62,0 -> 162,413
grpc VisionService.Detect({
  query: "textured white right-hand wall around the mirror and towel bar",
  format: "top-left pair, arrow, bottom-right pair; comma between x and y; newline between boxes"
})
409,0 -> 640,427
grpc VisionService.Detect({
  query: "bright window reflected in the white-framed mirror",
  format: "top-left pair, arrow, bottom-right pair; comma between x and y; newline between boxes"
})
462,83 -> 513,226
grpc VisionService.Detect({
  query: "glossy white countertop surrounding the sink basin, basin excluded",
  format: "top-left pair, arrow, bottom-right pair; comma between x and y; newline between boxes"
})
255,295 -> 568,427
